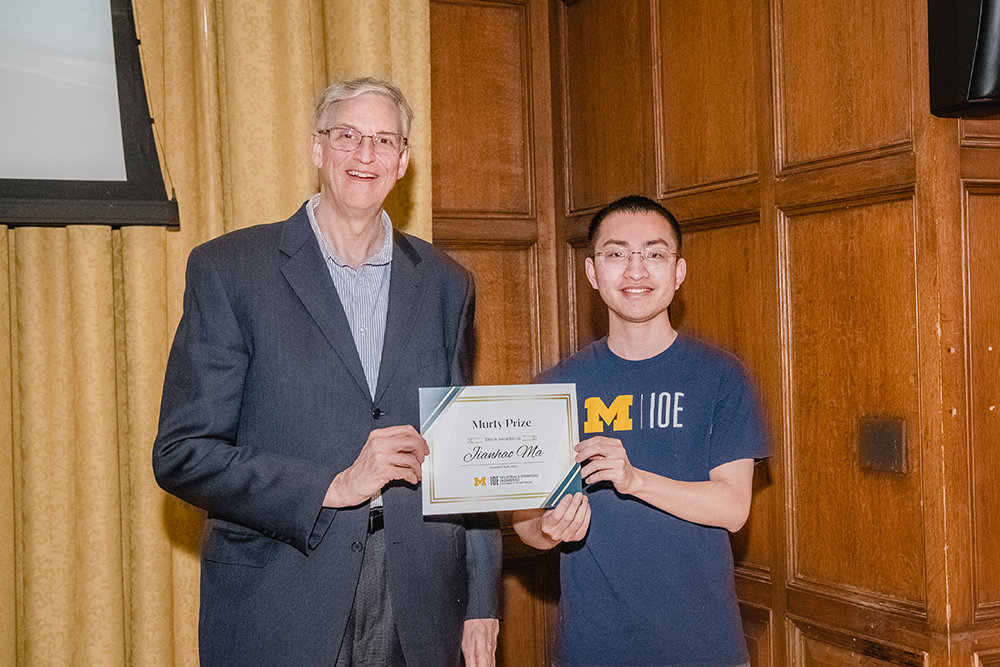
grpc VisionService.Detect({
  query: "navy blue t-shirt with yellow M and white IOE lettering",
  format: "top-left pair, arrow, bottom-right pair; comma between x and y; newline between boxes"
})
537,334 -> 768,667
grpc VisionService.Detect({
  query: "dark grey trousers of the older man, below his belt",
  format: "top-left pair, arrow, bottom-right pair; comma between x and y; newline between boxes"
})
336,530 -> 406,667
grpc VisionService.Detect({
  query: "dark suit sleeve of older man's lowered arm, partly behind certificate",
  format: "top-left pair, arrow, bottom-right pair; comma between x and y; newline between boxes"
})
452,281 -> 503,620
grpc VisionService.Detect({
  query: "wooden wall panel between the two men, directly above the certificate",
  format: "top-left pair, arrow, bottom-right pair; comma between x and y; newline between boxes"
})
442,244 -> 542,384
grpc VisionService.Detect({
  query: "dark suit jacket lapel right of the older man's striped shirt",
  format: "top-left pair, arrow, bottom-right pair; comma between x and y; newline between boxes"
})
375,231 -> 424,402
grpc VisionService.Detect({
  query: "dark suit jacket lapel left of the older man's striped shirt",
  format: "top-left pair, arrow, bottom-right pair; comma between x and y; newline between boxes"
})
279,202 -> 372,396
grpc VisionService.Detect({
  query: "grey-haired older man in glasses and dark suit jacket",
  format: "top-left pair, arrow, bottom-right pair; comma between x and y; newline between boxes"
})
153,78 -> 500,667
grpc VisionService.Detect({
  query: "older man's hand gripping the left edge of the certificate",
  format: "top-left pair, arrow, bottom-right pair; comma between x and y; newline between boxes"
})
323,424 -> 430,507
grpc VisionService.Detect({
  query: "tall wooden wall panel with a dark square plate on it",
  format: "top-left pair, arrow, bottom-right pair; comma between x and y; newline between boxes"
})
783,199 -> 926,616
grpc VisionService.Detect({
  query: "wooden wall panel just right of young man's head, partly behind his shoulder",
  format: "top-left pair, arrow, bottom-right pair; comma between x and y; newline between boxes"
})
670,221 -> 780,574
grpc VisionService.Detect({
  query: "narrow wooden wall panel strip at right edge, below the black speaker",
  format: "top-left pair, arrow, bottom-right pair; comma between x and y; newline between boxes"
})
966,185 -> 1000,618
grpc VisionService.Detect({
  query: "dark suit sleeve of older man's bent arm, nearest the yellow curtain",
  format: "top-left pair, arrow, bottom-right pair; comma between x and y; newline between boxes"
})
153,247 -> 336,552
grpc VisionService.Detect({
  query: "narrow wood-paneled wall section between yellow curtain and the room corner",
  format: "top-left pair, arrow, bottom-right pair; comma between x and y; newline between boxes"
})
430,0 -> 559,666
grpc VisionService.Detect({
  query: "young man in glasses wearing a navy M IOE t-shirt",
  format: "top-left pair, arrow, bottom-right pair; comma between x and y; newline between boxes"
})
514,196 -> 767,667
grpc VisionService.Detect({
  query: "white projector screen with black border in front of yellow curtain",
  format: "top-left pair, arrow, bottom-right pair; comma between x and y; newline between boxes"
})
0,0 -> 178,227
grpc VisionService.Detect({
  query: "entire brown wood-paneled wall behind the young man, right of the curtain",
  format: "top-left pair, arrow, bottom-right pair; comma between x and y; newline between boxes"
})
431,0 -> 1000,667
